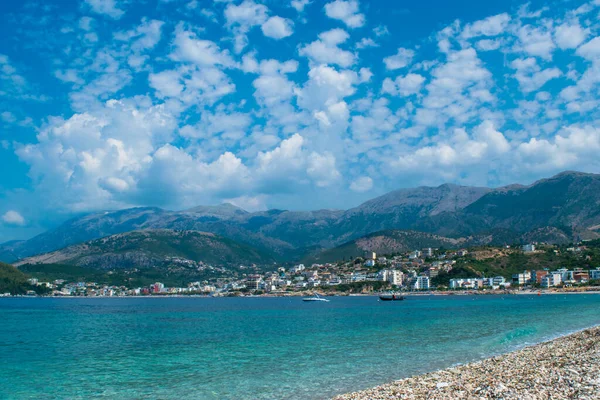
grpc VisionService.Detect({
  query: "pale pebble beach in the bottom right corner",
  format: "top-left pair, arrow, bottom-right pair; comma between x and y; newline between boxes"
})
335,326 -> 600,400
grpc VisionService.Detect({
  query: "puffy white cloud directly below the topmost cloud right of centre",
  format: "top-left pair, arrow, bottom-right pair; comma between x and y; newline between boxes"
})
299,29 -> 356,68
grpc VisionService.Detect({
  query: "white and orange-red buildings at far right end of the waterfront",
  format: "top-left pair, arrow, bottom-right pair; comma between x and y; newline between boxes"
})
512,268 -> 600,288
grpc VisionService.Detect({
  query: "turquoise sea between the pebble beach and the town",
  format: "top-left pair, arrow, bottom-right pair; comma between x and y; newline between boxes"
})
0,295 -> 600,399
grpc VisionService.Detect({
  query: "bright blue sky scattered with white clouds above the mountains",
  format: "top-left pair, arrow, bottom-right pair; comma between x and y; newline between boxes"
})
0,0 -> 600,242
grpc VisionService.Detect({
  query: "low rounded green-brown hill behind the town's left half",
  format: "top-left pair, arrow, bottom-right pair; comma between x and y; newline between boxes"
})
14,229 -> 274,269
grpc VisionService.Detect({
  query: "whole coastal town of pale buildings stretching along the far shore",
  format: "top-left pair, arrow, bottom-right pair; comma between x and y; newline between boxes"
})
8,244 -> 600,297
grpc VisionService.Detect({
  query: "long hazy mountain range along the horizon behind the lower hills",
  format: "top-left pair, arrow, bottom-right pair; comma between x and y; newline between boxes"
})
0,172 -> 600,268
